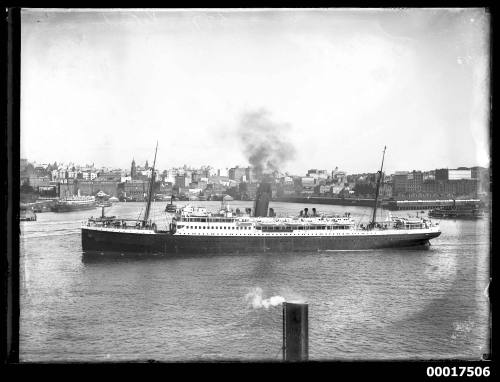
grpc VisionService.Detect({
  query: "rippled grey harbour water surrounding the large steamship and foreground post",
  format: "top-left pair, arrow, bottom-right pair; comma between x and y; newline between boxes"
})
19,201 -> 490,362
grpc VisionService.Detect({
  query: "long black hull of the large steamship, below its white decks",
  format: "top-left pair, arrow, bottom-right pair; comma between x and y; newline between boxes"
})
82,228 -> 440,255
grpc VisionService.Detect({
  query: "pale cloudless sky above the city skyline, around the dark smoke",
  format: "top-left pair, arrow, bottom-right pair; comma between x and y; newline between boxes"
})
20,8 -> 491,174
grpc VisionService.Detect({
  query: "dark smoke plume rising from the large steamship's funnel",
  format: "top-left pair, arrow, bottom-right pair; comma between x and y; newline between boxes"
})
238,109 -> 295,180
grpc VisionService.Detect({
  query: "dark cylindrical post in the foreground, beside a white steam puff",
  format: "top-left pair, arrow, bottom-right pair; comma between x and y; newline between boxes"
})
283,302 -> 309,361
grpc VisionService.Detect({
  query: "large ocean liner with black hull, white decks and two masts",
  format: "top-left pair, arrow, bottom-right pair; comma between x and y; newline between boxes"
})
82,144 -> 441,255
